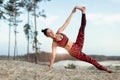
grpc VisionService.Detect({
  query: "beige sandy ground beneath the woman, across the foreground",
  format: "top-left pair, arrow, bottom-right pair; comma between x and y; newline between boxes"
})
0,60 -> 120,80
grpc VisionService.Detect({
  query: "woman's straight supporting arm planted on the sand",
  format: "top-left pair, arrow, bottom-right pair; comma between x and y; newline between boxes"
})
50,41 -> 57,69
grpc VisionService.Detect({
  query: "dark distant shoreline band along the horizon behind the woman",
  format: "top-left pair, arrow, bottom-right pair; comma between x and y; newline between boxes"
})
0,52 -> 120,62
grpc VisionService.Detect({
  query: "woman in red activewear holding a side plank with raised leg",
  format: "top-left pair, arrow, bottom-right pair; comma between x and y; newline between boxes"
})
42,6 -> 112,73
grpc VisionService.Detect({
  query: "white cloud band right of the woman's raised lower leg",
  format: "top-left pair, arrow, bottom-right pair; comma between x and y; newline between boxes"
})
87,13 -> 120,25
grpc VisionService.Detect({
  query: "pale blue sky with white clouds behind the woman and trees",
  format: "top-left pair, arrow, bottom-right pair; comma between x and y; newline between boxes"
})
0,0 -> 120,56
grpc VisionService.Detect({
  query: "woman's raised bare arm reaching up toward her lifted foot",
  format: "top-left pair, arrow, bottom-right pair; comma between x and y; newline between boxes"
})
57,7 -> 76,33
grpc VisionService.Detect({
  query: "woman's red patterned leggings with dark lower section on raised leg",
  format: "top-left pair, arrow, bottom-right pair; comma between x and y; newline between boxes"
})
69,14 -> 108,71
